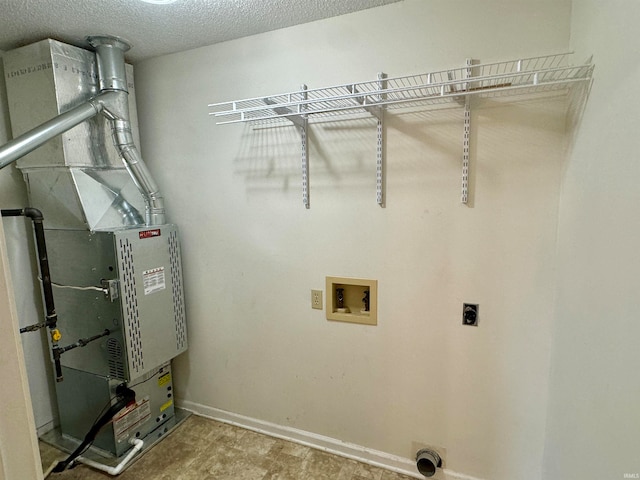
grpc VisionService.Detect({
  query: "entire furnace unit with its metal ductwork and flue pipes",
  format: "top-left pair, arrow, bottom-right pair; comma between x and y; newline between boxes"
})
0,36 -> 187,468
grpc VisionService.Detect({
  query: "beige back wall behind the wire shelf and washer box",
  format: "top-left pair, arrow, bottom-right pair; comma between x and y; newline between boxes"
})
136,0 -> 570,480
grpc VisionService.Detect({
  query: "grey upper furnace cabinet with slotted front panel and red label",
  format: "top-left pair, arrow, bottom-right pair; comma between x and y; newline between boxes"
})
47,225 -> 187,381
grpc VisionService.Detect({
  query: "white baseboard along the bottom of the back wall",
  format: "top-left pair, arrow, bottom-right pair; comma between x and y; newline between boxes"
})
176,399 -> 482,480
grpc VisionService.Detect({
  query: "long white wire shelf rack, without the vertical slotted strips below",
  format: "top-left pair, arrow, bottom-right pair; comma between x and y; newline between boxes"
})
209,53 -> 594,124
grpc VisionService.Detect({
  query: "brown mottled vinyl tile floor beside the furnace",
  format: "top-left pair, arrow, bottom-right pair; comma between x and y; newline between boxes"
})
40,415 -> 412,480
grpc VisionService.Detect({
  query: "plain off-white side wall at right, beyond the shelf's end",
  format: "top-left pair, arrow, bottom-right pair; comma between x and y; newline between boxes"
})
545,0 -> 640,480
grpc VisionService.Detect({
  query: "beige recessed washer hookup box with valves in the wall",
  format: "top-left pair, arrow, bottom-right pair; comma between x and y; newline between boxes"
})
326,277 -> 378,325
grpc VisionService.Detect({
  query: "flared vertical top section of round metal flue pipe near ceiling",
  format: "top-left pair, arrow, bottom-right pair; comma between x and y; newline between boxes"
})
87,35 -> 131,92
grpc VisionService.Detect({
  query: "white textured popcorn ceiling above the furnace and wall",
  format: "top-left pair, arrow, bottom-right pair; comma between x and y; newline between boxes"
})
0,0 -> 399,62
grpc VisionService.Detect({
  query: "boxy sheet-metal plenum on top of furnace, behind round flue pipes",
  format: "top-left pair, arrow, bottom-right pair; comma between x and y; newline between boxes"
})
4,39 -> 145,231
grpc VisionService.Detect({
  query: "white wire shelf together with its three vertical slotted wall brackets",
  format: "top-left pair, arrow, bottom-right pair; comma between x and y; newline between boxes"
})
209,53 -> 594,208
